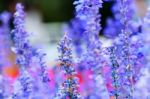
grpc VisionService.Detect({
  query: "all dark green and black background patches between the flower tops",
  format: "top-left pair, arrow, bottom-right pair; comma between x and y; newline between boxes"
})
0,0 -> 114,33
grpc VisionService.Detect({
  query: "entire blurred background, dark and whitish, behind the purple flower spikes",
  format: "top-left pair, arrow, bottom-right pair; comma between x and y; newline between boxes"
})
0,0 -> 150,77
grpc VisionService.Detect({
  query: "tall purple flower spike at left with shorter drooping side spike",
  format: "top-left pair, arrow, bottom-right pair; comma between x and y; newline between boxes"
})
12,3 -> 50,99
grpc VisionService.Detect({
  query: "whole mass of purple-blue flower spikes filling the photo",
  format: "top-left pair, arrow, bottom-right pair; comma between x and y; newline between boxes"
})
0,0 -> 150,99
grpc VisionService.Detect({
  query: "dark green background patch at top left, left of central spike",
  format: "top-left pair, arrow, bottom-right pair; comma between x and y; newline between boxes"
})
0,0 -> 73,22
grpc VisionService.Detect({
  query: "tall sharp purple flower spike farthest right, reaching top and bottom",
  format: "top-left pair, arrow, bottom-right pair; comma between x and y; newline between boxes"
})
114,0 -> 144,98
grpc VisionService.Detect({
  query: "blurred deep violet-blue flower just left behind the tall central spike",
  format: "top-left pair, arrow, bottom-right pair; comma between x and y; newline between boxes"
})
67,18 -> 86,57
